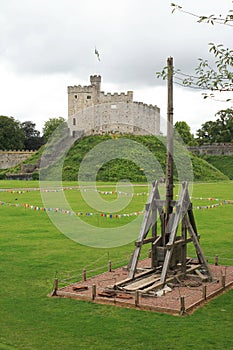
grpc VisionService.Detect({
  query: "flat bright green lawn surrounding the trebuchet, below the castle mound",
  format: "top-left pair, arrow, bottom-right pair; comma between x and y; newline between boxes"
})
0,181 -> 233,350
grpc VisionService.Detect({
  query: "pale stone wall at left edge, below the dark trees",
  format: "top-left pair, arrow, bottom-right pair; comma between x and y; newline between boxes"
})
0,150 -> 35,169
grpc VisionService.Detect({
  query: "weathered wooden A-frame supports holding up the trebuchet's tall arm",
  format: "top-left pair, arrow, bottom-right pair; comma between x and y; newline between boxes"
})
127,182 -> 212,286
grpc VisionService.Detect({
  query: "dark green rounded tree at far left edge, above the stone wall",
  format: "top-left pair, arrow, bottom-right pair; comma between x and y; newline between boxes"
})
0,115 -> 24,151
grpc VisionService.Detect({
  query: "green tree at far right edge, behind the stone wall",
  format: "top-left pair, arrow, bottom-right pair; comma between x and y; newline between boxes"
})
197,108 -> 233,145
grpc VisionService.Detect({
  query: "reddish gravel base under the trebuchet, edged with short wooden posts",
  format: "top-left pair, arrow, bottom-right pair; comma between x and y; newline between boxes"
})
56,259 -> 233,314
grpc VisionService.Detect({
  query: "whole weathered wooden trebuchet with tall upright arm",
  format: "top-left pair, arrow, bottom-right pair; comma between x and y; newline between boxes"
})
117,57 -> 212,292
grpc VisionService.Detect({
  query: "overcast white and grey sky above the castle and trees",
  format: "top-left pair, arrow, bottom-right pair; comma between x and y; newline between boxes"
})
0,0 -> 233,132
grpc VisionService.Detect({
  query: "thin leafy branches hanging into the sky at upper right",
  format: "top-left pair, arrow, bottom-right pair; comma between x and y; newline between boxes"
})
156,3 -> 233,101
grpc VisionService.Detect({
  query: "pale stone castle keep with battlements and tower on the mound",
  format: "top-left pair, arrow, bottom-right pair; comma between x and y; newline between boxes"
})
68,75 -> 160,136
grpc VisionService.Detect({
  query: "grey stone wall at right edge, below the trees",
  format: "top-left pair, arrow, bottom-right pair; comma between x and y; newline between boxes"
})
187,143 -> 233,156
